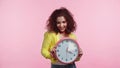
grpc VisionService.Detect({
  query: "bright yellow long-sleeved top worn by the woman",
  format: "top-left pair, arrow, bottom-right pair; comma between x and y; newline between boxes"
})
41,31 -> 76,63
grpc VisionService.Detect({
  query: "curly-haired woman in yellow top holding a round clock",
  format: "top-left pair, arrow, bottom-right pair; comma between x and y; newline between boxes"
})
41,7 -> 83,68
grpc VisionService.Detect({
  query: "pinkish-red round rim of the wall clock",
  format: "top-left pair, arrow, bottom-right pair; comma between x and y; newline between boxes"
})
55,37 -> 80,64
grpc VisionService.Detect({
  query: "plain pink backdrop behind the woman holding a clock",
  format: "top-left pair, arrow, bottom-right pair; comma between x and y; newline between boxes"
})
0,0 -> 120,68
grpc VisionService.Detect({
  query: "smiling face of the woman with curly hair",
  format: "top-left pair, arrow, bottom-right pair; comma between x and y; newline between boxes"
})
57,16 -> 67,33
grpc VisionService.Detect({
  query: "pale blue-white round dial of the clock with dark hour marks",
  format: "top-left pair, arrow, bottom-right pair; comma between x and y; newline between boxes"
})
56,39 -> 79,64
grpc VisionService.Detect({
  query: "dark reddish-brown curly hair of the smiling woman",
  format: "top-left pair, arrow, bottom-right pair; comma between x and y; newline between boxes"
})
47,7 -> 76,34
